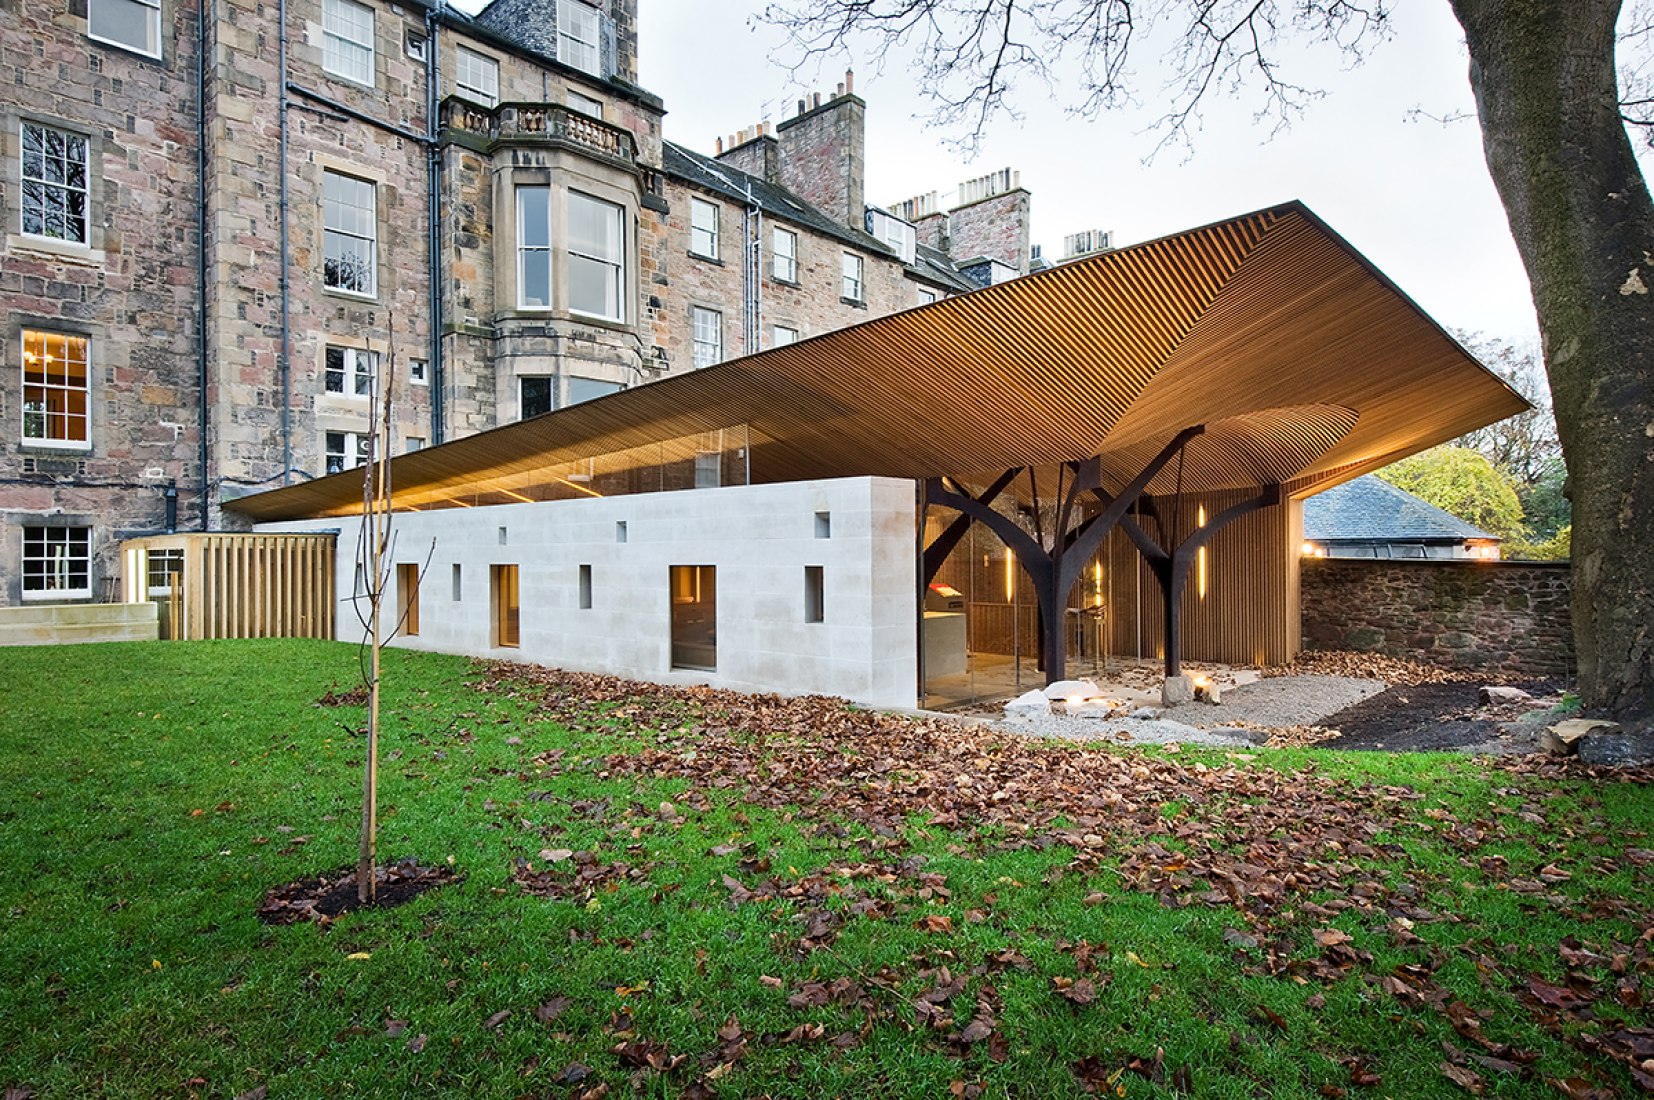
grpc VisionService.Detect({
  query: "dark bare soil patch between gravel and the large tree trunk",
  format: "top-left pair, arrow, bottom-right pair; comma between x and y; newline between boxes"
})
1318,680 -> 1561,753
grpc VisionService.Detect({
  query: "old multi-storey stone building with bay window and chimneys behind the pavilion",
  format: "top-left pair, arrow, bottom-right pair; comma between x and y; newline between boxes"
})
0,0 -> 1029,605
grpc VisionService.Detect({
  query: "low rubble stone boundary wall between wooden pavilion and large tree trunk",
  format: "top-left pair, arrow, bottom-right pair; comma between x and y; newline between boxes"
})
1302,557 -> 1573,677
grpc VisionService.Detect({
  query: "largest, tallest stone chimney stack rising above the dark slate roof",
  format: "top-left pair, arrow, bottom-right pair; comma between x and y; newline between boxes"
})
776,71 -> 867,228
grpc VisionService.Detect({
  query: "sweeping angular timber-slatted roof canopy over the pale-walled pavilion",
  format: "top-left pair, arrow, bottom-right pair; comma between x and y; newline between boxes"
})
225,202 -> 1527,519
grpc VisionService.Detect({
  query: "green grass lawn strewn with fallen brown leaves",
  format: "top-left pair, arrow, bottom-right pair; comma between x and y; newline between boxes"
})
0,642 -> 1654,1098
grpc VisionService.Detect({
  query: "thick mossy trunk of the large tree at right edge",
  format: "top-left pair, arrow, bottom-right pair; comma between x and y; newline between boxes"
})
1449,0 -> 1654,720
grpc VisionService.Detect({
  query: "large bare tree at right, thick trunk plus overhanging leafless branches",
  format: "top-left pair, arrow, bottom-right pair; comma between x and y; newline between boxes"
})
761,0 -> 1654,720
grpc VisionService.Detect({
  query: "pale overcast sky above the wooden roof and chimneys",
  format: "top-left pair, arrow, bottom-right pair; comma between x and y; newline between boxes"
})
625,0 -> 1537,341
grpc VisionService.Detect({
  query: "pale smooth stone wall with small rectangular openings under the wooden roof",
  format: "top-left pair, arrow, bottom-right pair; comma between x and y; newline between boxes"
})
260,478 -> 918,706
